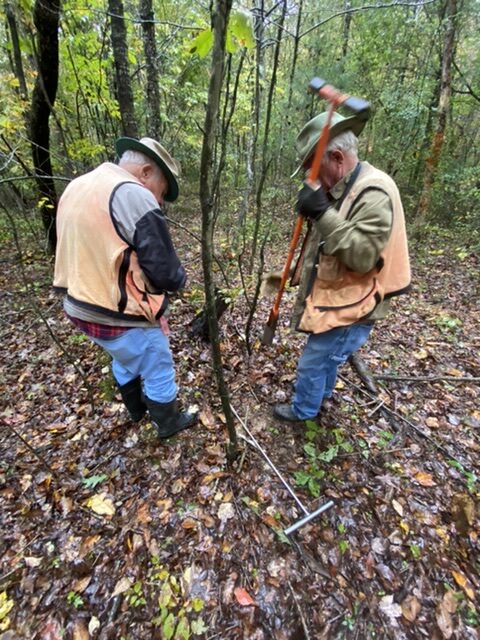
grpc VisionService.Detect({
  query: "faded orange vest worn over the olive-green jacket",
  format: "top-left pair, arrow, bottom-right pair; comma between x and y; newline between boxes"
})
297,163 -> 410,333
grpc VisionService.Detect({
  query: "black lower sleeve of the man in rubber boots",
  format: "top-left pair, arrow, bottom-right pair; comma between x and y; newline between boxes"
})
133,209 -> 187,291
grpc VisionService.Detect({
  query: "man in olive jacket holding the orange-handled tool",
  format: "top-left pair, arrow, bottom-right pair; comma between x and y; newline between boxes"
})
273,113 -> 410,422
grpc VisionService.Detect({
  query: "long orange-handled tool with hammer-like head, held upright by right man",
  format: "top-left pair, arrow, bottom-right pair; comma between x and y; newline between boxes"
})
262,78 -> 370,345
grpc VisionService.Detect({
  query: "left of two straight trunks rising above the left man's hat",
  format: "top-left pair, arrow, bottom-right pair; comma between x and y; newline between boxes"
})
108,0 -> 138,138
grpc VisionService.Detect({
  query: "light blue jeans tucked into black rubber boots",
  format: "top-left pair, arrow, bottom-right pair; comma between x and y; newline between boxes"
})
92,327 -> 177,403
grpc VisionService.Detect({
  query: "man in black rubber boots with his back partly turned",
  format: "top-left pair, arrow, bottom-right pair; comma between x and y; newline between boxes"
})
54,138 -> 196,438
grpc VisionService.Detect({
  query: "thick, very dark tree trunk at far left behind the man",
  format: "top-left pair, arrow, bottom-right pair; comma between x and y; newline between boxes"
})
30,0 -> 60,253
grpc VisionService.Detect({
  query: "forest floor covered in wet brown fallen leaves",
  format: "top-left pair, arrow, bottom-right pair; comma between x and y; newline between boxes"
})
0,211 -> 480,640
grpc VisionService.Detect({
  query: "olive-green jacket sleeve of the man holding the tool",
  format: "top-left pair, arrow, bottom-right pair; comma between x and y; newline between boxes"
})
316,189 -> 393,273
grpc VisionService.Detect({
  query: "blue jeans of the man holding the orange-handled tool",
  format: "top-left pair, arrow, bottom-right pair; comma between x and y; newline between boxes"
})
293,324 -> 372,420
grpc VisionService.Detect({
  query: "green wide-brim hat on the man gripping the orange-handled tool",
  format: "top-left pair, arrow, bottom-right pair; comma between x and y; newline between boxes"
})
291,111 -> 367,178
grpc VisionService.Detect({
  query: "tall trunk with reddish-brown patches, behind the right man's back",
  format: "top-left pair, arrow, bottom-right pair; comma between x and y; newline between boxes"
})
415,0 -> 457,226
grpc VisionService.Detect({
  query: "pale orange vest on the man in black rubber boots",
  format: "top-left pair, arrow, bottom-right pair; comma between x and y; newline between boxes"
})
54,163 -> 167,322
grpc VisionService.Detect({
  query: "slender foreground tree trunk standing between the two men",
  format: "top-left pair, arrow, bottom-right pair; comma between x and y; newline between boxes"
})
200,0 -> 237,458
